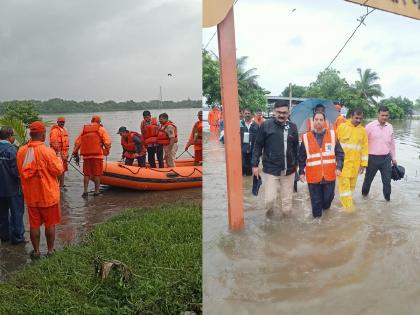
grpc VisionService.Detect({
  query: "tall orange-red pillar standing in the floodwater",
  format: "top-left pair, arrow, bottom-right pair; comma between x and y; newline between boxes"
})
217,7 -> 244,230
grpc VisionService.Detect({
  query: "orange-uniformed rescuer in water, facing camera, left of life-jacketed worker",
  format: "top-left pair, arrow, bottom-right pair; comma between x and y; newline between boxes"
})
50,117 -> 70,187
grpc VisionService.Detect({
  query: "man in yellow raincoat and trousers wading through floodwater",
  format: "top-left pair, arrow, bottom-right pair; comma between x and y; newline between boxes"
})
337,109 -> 368,209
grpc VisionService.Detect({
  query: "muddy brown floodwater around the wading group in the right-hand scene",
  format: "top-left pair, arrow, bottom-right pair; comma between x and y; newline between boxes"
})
203,120 -> 420,315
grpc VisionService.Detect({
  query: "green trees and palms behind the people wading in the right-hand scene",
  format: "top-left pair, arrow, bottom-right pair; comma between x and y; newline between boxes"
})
202,50 -> 420,119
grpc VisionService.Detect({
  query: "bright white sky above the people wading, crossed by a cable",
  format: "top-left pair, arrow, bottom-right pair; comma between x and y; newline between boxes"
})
203,0 -> 420,100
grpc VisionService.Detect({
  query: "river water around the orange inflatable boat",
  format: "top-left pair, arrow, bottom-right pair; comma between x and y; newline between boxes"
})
0,109 -> 202,281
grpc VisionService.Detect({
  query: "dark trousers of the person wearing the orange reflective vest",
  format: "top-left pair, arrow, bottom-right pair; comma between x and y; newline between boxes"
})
308,182 -> 335,218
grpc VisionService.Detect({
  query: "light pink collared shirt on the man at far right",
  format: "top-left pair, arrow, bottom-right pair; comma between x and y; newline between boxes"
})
365,120 -> 396,160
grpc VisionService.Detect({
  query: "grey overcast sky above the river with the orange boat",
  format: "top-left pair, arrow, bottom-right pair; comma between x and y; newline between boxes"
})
0,0 -> 202,101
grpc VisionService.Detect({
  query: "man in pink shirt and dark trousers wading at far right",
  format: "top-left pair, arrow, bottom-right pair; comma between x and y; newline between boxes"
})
362,106 -> 397,201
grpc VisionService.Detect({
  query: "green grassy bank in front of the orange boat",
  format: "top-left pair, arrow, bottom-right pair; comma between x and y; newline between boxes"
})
0,203 -> 202,314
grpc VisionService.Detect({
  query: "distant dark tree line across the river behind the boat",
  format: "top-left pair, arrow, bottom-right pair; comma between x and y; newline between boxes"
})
0,98 -> 202,116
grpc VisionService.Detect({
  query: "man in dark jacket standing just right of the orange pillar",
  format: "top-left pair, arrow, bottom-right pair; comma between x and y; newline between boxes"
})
240,108 -> 259,176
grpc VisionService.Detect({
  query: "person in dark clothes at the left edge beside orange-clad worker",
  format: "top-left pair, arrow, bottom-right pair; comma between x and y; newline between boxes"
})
0,127 -> 25,245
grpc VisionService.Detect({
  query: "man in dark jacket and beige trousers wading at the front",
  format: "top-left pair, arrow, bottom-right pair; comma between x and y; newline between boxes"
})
252,102 -> 299,215
